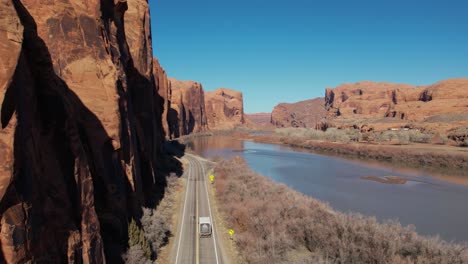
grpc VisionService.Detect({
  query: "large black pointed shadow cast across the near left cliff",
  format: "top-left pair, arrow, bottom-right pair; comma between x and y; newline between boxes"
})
0,0 -> 138,263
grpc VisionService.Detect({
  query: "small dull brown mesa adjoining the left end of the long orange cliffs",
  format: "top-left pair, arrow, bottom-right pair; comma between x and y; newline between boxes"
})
271,98 -> 326,128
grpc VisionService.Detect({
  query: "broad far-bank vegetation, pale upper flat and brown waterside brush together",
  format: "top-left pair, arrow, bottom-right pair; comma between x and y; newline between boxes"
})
268,128 -> 468,171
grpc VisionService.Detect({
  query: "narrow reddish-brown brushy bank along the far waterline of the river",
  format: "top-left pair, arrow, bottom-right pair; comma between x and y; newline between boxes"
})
238,133 -> 468,176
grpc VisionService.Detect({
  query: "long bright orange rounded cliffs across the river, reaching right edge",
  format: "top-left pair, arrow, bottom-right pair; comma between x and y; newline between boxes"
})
325,78 -> 468,129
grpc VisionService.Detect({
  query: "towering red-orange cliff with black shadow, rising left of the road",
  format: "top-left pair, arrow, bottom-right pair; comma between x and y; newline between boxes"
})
0,0 -> 168,263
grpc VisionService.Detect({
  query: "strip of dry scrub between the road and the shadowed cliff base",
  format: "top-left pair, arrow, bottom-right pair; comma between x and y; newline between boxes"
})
124,174 -> 180,264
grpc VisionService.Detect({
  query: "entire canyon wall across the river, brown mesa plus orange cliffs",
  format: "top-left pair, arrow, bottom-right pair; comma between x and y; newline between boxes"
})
271,78 -> 468,131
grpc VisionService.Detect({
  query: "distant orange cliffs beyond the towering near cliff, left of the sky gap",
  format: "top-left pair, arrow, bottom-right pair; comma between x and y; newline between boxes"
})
153,68 -> 245,138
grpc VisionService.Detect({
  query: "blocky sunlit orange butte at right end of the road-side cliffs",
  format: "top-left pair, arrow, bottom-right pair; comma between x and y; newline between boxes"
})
205,88 -> 245,130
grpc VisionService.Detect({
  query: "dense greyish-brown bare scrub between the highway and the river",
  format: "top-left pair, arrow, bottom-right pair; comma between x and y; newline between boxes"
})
215,157 -> 468,263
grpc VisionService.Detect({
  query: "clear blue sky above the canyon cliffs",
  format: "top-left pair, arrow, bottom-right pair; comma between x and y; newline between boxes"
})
149,0 -> 468,113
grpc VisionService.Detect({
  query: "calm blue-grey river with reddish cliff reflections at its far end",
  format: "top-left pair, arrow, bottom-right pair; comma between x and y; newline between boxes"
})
189,136 -> 468,241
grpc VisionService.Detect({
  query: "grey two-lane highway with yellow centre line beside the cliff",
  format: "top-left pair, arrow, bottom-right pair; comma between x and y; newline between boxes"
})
172,154 -> 226,264
